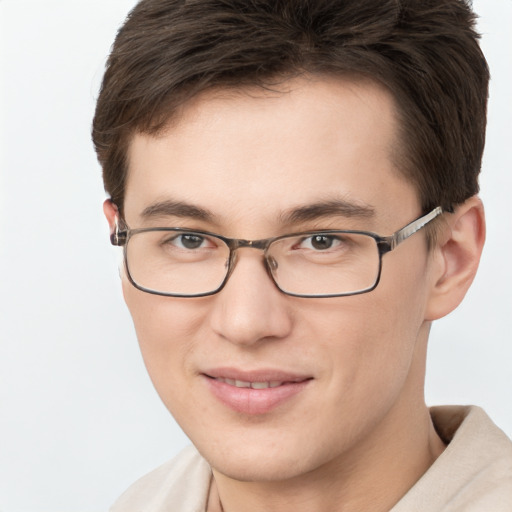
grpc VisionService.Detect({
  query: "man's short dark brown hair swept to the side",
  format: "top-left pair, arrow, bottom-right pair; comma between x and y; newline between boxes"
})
92,0 -> 489,212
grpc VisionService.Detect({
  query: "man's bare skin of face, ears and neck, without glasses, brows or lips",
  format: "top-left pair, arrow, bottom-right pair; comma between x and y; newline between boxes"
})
105,78 -> 484,512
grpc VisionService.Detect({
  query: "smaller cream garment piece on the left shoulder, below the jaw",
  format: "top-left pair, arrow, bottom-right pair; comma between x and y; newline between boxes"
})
110,446 -> 211,512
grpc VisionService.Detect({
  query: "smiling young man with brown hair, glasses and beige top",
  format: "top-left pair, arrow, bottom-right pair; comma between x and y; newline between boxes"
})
93,0 -> 512,512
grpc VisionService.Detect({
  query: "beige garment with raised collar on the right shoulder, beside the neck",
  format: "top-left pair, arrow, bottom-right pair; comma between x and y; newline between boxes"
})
392,406 -> 512,512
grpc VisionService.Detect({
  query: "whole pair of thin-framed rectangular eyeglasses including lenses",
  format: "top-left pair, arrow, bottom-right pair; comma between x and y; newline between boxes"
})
111,207 -> 442,297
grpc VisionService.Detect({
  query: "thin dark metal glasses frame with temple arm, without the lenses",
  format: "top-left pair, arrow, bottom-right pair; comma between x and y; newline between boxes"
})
110,206 -> 443,298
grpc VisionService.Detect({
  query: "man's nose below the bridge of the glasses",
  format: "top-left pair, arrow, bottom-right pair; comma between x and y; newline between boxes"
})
211,248 -> 293,346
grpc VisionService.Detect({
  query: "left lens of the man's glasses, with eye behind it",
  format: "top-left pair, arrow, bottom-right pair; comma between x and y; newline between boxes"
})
126,230 -> 229,296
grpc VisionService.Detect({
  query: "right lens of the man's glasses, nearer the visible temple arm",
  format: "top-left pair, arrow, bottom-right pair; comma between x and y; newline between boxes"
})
267,232 -> 380,297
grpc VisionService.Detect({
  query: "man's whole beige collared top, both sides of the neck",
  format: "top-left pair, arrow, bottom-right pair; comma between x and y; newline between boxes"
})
111,406 -> 512,512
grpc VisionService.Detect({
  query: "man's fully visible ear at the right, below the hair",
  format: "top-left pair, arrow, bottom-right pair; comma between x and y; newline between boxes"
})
425,196 -> 485,320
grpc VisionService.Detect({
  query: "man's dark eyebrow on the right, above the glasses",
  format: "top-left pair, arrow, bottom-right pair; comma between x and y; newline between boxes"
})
281,199 -> 375,224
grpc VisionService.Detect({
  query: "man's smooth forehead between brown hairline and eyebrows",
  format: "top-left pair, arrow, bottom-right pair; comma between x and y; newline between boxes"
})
124,79 -> 416,232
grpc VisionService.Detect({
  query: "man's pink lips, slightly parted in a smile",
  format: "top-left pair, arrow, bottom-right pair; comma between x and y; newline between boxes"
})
202,368 -> 312,415
